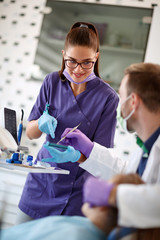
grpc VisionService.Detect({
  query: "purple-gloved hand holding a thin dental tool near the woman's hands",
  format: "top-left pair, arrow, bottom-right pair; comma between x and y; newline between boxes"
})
61,128 -> 94,158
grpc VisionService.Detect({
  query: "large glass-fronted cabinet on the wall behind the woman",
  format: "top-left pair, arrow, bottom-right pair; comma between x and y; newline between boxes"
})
32,0 -> 153,90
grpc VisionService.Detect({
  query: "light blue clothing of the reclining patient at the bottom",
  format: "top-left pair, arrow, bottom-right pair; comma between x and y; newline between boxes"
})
0,216 -> 106,240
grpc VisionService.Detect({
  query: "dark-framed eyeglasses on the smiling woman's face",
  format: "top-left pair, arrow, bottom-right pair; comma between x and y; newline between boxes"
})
64,59 -> 95,69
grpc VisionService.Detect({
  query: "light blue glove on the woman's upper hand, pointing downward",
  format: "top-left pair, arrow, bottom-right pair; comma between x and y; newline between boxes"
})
38,111 -> 57,138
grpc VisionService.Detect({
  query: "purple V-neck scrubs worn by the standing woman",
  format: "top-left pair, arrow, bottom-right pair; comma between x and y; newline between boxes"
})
19,72 -> 118,219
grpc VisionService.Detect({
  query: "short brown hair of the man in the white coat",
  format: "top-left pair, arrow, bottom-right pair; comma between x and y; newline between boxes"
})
125,63 -> 160,112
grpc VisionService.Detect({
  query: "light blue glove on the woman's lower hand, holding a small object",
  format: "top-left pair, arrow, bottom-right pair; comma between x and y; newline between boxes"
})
41,142 -> 81,163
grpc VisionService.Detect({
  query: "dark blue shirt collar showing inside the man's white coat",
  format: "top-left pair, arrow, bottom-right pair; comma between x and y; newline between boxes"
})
137,127 -> 160,157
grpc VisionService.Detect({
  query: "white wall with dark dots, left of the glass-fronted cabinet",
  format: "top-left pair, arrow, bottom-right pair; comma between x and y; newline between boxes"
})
0,0 -> 46,158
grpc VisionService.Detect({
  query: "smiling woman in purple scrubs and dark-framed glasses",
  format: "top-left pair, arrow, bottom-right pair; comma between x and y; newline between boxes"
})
17,22 -> 118,223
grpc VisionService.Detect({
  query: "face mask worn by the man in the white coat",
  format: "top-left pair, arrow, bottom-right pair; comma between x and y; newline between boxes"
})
117,95 -> 135,131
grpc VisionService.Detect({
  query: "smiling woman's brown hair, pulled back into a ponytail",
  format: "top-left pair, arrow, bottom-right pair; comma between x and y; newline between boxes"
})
59,22 -> 100,79
